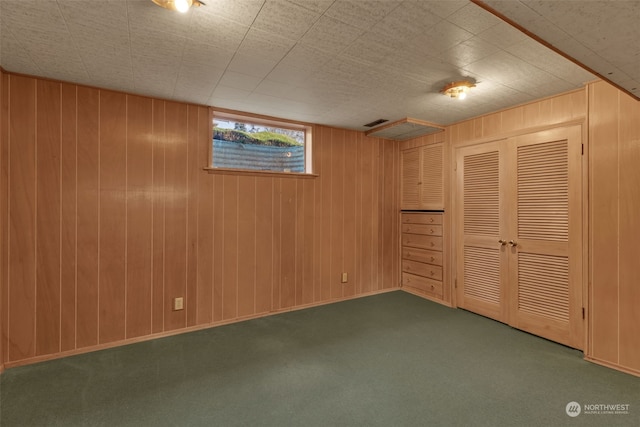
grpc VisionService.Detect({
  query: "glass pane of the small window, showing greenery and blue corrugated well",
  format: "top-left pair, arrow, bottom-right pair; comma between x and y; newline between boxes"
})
212,117 -> 305,173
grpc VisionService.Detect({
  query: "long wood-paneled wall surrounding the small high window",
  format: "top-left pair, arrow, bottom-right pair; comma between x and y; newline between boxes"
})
0,73 -> 399,366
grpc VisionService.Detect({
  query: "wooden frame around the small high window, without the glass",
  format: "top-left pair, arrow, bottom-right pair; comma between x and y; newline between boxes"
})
204,108 -> 318,178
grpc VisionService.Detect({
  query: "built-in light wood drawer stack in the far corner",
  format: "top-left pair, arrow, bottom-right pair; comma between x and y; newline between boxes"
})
401,212 -> 443,299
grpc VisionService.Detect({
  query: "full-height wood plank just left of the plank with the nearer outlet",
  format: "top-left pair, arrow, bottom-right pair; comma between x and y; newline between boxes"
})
151,100 -> 167,333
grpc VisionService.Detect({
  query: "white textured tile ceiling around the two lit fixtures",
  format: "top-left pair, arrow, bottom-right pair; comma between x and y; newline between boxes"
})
0,0 -> 639,130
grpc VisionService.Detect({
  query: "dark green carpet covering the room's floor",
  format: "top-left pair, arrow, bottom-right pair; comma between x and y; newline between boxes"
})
0,291 -> 640,427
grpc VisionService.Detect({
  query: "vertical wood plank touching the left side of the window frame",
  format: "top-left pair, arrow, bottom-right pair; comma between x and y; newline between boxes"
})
194,108 -> 214,325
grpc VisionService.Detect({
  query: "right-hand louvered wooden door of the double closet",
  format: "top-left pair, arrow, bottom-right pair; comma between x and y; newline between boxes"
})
507,126 -> 583,348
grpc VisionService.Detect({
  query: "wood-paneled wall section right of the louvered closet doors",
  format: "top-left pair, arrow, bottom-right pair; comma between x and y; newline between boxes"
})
588,82 -> 640,375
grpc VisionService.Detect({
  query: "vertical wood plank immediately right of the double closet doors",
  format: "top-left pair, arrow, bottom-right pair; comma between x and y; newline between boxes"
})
589,85 -> 619,363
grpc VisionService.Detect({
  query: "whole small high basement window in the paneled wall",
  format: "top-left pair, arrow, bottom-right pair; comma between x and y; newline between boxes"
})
208,112 -> 311,175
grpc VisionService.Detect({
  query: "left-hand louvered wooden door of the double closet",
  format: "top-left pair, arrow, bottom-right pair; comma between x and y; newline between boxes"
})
456,142 -> 508,322
